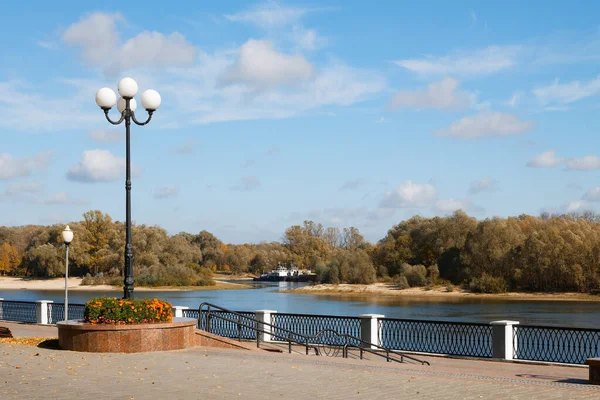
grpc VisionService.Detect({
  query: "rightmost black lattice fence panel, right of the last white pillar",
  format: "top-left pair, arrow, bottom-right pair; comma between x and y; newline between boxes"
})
513,325 -> 600,364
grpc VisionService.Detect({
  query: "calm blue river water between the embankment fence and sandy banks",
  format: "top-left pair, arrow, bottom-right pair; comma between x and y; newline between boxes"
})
0,282 -> 600,328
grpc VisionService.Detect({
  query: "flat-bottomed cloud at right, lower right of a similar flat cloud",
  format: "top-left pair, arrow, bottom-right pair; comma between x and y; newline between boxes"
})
435,111 -> 533,139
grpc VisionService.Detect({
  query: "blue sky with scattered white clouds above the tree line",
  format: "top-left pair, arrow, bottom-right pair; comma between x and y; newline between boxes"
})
0,1 -> 600,243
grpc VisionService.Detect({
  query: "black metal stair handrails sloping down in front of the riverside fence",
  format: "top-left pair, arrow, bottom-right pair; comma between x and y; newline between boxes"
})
198,302 -> 430,365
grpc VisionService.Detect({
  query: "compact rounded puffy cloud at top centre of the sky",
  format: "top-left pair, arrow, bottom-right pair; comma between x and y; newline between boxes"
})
225,39 -> 313,87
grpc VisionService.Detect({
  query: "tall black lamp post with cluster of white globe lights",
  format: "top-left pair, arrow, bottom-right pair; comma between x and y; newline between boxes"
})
96,78 -> 161,299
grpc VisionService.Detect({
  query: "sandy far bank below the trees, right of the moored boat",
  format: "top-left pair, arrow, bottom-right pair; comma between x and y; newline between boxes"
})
281,283 -> 600,301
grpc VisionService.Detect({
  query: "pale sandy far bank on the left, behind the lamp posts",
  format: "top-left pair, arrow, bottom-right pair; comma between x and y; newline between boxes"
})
0,276 -> 250,292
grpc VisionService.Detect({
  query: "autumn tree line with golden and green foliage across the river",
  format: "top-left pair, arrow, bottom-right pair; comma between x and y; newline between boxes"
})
0,210 -> 600,293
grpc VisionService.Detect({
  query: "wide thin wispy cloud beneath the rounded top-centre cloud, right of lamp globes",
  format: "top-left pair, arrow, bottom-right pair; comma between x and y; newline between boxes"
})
169,50 -> 386,124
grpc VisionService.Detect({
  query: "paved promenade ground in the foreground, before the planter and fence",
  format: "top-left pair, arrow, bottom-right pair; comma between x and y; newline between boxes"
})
0,345 -> 600,400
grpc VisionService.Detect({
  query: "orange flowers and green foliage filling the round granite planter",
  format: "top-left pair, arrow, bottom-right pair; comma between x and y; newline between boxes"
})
83,297 -> 173,325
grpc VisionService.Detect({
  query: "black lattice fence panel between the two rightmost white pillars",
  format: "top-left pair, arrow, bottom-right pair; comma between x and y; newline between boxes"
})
378,318 -> 492,358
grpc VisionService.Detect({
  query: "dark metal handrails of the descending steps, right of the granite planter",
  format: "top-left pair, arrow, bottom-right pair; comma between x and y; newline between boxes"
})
198,303 -> 430,365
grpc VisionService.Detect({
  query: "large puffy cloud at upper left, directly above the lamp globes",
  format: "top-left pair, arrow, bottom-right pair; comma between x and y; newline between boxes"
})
62,12 -> 197,74
